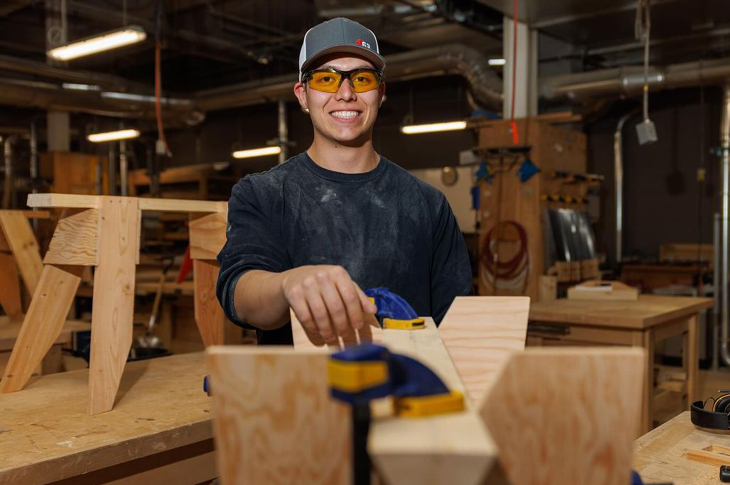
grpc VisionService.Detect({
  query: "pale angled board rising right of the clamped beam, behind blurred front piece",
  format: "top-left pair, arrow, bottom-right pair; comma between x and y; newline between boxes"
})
439,296 -> 530,403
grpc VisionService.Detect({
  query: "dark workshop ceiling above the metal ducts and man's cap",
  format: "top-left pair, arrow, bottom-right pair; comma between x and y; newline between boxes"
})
0,0 -> 730,104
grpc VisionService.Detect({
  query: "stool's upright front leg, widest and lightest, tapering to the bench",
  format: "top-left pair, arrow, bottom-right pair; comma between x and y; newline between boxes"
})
89,197 -> 139,414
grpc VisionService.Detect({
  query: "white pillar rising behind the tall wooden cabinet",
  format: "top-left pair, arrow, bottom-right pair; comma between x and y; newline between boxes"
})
502,16 -> 537,119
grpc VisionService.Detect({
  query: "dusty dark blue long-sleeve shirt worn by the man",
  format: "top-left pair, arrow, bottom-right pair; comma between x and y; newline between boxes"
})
217,152 -> 472,344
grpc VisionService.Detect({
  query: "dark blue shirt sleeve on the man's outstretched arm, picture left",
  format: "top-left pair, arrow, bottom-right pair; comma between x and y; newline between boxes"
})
216,175 -> 291,328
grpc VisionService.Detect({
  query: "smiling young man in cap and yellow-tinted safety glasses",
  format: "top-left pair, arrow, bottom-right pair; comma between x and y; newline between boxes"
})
217,18 -> 471,344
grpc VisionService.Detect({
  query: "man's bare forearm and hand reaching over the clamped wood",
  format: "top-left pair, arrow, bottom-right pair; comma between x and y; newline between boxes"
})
234,265 -> 376,345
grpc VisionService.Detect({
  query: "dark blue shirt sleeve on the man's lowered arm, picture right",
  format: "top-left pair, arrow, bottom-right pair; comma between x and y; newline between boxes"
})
431,196 -> 472,325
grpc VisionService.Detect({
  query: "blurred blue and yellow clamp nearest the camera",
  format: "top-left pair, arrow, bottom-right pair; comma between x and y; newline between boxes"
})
327,343 -> 464,418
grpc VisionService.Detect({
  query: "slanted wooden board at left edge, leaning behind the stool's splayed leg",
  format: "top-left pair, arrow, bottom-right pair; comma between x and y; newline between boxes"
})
0,211 -> 43,295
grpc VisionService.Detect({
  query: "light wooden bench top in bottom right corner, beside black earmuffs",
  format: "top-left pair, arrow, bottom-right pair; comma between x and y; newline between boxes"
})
633,411 -> 730,485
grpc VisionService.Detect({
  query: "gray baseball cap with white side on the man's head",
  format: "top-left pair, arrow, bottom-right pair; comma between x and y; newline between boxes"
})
299,17 -> 385,79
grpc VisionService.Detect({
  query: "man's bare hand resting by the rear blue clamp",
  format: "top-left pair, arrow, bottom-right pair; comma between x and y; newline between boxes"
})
281,265 -> 377,344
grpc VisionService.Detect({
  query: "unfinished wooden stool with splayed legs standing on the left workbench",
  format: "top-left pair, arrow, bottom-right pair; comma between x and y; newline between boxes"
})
0,194 -> 227,414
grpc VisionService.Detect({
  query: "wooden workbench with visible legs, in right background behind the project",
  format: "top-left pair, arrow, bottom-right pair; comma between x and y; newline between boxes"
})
527,295 -> 714,434
